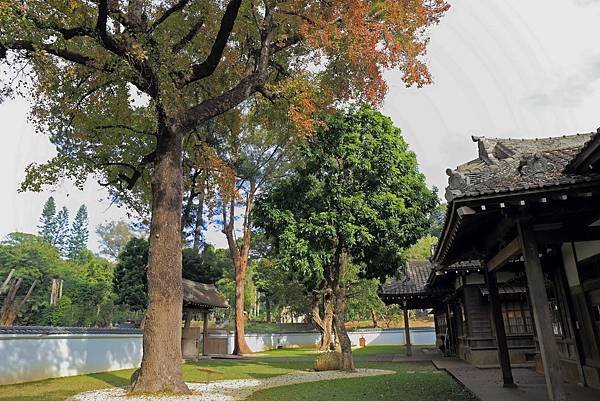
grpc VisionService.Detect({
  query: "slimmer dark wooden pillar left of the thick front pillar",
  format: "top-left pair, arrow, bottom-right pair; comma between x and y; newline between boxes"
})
484,260 -> 516,387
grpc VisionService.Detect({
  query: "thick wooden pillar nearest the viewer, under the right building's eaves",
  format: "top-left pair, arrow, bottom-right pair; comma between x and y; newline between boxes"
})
517,221 -> 567,401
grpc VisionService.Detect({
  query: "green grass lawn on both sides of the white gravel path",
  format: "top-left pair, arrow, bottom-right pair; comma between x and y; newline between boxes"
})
0,347 -> 475,401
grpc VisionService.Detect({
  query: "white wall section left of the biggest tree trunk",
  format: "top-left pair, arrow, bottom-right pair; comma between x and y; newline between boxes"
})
0,334 -> 142,385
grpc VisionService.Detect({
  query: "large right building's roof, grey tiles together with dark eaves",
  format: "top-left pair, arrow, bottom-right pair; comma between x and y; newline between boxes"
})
433,130 -> 600,268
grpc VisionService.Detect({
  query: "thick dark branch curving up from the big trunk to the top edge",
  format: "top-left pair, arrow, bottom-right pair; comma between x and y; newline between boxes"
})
185,0 -> 242,85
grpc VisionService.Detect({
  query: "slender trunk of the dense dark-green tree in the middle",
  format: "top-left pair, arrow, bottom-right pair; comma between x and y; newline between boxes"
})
332,249 -> 355,371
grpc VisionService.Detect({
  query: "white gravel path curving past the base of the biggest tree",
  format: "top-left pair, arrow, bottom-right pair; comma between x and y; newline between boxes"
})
70,369 -> 395,401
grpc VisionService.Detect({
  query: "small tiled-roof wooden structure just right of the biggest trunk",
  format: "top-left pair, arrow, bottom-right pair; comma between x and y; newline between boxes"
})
181,279 -> 229,358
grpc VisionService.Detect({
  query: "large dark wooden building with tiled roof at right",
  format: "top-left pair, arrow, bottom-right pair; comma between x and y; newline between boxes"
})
381,130 -> 600,400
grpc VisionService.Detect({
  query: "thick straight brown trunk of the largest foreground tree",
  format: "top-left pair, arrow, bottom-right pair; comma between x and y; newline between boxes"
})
131,127 -> 189,393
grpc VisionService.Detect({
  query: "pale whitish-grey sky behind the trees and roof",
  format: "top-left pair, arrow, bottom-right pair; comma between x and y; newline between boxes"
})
0,0 -> 600,250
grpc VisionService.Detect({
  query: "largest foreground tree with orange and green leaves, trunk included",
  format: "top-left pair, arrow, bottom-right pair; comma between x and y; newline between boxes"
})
0,0 -> 448,393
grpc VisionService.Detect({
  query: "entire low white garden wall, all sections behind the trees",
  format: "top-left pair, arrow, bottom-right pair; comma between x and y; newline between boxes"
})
0,328 -> 435,385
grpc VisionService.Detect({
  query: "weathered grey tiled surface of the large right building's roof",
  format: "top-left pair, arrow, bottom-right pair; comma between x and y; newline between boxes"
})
446,133 -> 600,201
